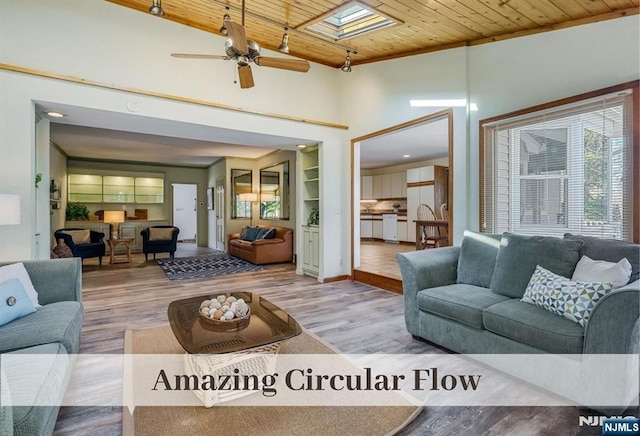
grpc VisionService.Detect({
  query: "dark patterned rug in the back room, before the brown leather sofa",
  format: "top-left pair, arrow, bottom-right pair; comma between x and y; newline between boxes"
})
156,252 -> 264,280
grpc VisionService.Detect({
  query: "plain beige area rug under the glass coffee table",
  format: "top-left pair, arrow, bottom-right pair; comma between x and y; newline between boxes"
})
122,326 -> 421,436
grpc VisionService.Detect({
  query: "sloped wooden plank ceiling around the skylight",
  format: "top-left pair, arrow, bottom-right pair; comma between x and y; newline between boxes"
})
107,0 -> 640,67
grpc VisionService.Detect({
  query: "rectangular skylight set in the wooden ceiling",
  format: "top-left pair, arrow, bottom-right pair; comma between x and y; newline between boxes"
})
301,1 -> 398,41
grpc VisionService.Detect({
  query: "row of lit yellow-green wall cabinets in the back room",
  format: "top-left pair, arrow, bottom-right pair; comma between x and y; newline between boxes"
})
67,174 -> 164,203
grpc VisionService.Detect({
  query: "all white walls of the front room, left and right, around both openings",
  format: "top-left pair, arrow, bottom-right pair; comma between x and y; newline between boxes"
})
0,0 -> 640,270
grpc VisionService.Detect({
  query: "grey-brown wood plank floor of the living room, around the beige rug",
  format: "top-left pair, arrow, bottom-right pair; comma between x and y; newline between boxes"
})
55,244 -> 616,436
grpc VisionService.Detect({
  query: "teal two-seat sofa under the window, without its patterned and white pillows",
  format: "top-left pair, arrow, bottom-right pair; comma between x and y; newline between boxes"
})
396,232 -> 640,412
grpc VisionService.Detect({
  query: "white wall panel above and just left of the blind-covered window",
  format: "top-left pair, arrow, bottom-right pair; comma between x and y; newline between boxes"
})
468,15 -> 640,230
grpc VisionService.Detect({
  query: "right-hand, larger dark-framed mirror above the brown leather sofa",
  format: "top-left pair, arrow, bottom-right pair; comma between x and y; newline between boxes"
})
260,161 -> 290,220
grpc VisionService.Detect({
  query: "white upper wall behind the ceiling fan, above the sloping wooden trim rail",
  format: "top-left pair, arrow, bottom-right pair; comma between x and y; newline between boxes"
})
0,0 -> 338,122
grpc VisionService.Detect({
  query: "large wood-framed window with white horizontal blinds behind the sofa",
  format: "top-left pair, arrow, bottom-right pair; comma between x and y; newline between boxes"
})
480,82 -> 640,241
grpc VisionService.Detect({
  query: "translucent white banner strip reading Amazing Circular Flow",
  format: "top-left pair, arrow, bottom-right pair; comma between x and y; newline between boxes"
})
0,353 -> 639,410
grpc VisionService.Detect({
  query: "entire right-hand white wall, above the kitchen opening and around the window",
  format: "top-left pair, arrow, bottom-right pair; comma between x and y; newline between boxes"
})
340,15 -> 640,243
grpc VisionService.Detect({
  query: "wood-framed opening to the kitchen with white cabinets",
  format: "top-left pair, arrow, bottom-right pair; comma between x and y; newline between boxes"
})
351,109 -> 453,293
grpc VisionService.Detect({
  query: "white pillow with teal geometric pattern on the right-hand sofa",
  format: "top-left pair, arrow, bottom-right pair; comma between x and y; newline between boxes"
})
520,265 -> 613,327
